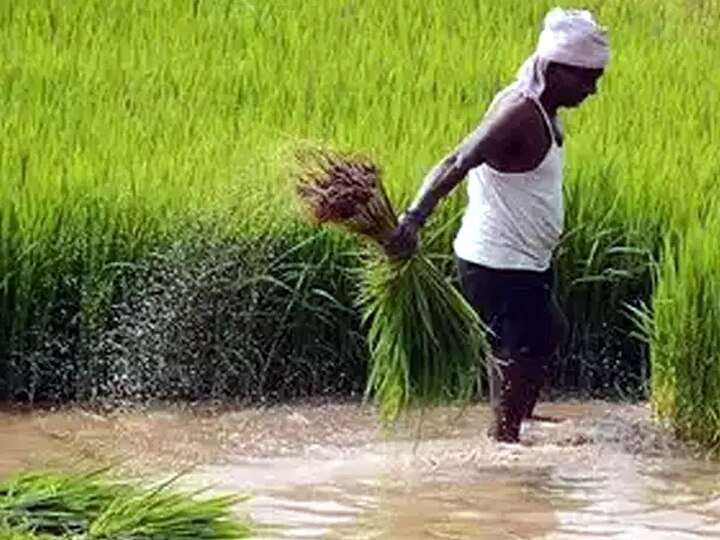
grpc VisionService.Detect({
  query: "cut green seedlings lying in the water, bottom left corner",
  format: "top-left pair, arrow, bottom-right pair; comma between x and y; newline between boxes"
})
0,471 -> 251,540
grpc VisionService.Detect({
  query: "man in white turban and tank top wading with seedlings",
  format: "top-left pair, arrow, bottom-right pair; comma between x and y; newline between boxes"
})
388,8 -> 609,443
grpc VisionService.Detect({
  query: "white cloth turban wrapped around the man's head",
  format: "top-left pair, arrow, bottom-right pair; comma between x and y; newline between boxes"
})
514,8 -> 610,99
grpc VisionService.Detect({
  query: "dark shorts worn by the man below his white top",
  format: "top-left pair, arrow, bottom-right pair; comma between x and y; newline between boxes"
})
456,258 -> 556,358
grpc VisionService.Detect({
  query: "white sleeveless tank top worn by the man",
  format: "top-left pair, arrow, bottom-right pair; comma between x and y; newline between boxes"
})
453,90 -> 564,272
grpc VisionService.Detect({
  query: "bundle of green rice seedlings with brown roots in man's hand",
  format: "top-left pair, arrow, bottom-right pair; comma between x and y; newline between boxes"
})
294,149 -> 488,423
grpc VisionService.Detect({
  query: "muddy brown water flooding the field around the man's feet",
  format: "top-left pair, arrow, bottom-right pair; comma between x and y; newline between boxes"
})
0,403 -> 720,540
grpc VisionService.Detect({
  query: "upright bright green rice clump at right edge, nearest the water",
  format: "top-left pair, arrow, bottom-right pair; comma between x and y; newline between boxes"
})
635,218 -> 720,452
